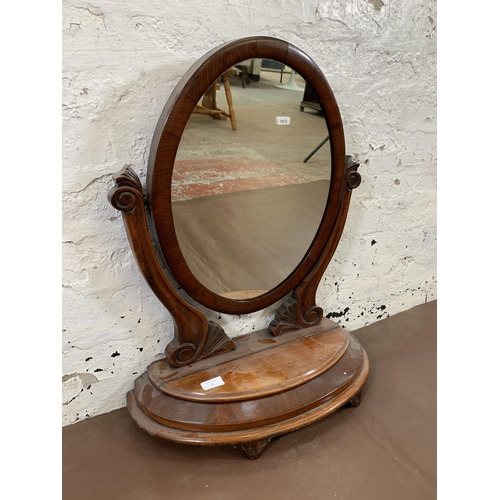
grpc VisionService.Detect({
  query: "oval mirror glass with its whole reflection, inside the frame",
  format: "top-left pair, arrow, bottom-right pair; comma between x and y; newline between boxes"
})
172,59 -> 331,300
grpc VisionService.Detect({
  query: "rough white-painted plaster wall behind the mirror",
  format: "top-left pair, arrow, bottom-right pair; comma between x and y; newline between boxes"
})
62,0 -> 436,425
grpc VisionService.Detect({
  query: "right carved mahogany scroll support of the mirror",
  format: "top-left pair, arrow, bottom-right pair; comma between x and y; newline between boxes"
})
268,156 -> 361,337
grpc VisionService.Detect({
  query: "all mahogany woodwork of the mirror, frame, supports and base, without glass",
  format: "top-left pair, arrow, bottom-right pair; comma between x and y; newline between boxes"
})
109,37 -> 369,459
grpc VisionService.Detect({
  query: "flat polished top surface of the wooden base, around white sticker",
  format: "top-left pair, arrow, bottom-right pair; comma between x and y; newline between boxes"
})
148,320 -> 349,402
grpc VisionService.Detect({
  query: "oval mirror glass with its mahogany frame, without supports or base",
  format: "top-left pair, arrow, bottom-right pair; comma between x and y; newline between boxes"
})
148,37 -> 345,314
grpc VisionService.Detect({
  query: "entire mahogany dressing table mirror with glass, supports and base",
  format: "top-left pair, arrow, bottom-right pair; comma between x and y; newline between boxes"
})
109,37 -> 369,459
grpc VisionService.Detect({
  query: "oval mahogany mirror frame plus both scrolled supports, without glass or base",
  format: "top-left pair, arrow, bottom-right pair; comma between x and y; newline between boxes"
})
108,37 -> 361,367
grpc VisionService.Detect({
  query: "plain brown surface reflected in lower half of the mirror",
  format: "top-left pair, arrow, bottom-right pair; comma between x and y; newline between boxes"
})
174,180 -> 329,294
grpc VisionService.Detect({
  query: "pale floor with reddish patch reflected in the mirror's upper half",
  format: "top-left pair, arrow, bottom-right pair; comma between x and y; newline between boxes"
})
172,72 -> 330,201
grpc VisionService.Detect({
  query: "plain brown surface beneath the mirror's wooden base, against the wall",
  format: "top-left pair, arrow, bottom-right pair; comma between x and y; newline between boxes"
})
63,302 -> 437,500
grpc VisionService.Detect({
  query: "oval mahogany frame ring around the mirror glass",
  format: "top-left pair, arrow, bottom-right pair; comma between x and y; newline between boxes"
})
147,37 -> 354,314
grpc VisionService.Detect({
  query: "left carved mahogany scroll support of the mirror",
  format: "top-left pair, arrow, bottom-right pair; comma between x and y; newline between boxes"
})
108,165 -> 235,367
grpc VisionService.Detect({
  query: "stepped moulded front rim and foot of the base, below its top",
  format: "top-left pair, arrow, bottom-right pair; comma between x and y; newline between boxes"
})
127,325 -> 369,459
